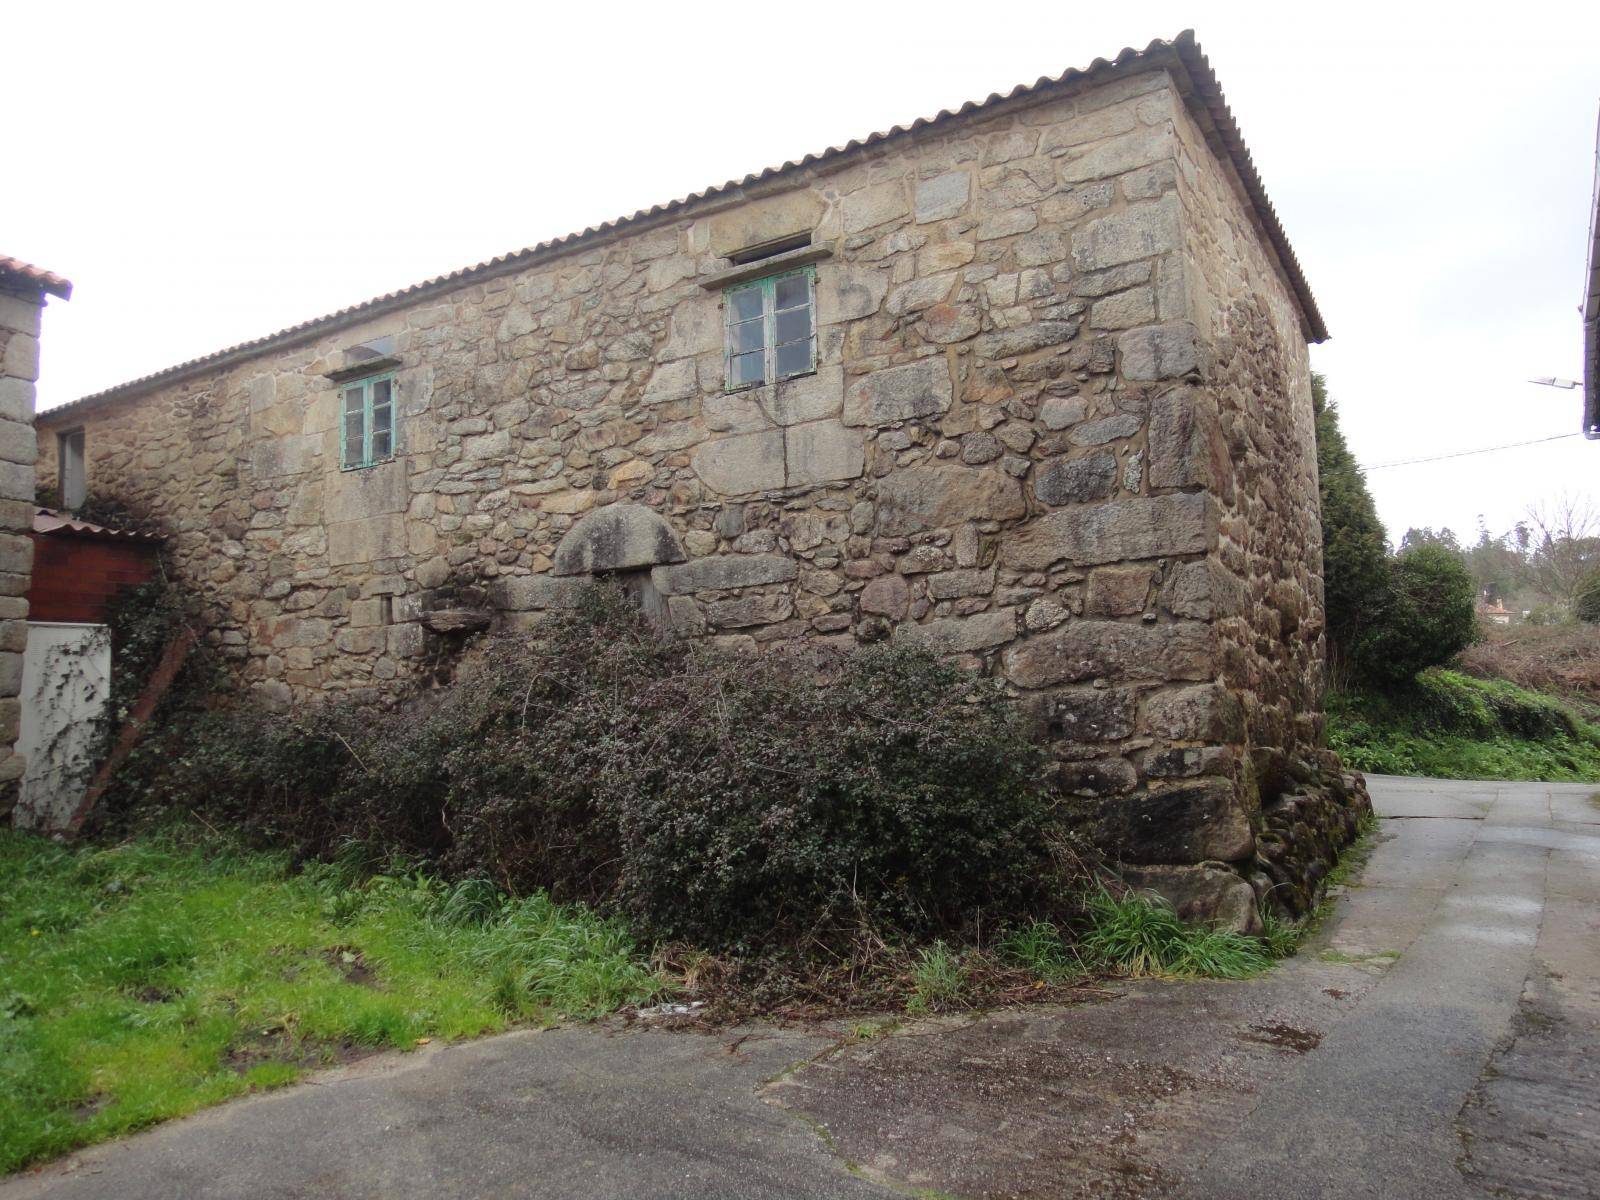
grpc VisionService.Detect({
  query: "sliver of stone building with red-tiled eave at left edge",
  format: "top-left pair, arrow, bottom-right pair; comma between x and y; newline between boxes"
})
0,254 -> 72,821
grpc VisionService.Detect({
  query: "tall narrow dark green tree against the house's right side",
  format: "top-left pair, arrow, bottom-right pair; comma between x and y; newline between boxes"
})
1310,374 -> 1389,678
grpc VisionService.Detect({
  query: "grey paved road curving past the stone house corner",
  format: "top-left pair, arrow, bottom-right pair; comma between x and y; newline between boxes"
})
0,778 -> 1600,1200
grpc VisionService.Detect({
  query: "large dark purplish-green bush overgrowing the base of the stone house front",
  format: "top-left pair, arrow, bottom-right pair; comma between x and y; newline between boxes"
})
103,589 -> 1053,952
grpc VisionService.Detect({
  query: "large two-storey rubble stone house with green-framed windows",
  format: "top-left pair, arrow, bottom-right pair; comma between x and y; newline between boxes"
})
38,34 -> 1363,925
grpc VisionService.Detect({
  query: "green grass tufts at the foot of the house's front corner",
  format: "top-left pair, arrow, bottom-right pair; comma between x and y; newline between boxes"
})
1080,888 -> 1274,979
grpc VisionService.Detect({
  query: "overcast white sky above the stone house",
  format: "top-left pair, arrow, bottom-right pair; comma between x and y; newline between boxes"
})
0,0 -> 1600,538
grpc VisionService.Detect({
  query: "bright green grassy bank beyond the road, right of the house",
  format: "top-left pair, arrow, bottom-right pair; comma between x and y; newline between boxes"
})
1328,670 -> 1600,782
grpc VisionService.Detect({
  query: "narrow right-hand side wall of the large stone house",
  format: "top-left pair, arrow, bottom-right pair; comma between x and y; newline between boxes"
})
1152,96 -> 1371,912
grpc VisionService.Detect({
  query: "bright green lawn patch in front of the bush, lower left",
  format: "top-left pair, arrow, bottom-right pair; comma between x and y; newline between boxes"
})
0,830 -> 662,1174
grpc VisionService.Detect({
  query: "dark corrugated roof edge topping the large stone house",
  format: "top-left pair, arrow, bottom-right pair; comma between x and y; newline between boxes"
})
38,29 -> 1328,421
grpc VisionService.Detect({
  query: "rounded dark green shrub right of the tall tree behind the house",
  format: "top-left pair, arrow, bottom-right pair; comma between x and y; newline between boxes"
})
1355,546 -> 1477,683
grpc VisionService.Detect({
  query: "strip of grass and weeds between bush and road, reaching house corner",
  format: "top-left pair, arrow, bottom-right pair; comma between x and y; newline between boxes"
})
0,826 -> 1358,1174
